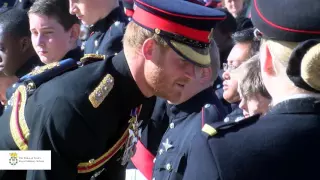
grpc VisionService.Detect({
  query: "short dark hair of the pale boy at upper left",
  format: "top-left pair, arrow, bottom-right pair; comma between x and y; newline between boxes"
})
28,0 -> 79,31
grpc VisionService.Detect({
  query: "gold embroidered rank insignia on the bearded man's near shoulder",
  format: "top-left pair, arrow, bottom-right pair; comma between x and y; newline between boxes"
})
89,74 -> 114,108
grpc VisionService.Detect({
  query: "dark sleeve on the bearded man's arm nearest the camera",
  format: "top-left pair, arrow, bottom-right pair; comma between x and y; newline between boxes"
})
26,98 -> 93,180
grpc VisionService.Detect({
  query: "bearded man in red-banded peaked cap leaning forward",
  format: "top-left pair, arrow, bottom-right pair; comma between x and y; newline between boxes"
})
1,0 -> 225,180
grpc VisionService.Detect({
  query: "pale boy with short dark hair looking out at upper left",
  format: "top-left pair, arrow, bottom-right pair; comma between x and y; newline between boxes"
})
28,0 -> 82,64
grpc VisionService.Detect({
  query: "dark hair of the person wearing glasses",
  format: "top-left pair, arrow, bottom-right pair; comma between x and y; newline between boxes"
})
232,28 -> 260,57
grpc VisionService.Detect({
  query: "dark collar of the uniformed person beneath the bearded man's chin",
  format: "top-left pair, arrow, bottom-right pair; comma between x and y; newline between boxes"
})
167,87 -> 214,118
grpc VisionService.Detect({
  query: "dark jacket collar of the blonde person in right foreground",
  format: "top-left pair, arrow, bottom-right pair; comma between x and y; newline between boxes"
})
269,96 -> 320,114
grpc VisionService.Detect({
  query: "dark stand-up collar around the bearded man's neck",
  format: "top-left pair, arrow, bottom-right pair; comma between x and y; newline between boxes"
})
111,51 -> 146,107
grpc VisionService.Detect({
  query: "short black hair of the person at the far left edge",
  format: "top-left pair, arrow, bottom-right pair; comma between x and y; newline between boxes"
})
0,8 -> 31,38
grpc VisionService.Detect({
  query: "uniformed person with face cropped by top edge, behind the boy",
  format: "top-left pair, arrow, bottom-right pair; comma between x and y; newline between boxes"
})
69,0 -> 128,56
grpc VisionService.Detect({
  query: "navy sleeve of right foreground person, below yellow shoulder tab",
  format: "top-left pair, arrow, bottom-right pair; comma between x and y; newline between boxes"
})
183,134 -> 220,180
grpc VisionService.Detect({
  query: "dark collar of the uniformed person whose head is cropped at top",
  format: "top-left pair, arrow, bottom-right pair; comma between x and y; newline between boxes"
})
90,7 -> 123,32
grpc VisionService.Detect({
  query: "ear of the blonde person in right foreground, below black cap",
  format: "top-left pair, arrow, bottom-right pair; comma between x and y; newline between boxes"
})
260,44 -> 276,76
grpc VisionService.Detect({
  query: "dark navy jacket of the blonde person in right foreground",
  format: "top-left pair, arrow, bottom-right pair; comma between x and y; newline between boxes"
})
184,97 -> 320,180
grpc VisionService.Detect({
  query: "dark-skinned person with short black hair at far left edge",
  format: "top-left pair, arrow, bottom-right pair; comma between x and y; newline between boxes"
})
0,8 -> 42,99
